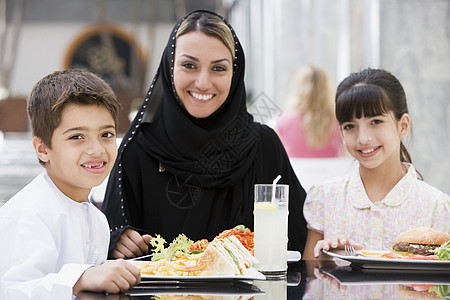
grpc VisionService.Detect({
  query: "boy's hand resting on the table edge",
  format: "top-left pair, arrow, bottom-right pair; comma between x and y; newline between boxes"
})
73,260 -> 141,295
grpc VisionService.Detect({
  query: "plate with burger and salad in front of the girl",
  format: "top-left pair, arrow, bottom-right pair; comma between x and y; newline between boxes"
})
322,227 -> 450,273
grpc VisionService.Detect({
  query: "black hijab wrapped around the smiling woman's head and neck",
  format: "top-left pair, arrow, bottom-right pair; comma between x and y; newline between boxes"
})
134,11 -> 257,188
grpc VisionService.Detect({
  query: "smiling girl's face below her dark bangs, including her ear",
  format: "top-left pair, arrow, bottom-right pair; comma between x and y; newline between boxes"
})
341,112 -> 410,169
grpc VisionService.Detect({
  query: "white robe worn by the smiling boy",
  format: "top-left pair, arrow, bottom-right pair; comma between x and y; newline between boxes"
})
0,172 -> 109,300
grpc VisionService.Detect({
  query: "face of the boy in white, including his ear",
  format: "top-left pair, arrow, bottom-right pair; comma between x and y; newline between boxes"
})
33,104 -> 117,202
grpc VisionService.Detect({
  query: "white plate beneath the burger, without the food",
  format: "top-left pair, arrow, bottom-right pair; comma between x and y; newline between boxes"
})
322,250 -> 450,272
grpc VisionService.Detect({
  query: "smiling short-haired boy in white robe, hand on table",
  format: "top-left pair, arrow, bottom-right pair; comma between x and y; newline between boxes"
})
0,70 -> 140,300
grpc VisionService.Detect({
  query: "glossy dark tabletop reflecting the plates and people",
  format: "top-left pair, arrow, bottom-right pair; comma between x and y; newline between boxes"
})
76,260 -> 450,300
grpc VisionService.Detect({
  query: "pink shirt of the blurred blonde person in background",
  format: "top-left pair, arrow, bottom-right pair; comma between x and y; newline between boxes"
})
276,111 -> 344,158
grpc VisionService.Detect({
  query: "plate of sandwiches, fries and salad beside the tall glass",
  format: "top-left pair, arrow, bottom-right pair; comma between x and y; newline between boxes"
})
129,227 -> 265,283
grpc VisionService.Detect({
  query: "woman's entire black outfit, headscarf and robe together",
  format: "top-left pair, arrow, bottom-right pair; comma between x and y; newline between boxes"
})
103,11 -> 306,254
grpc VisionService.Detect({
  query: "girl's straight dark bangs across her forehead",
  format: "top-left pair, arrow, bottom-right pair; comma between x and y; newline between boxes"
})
336,85 -> 389,124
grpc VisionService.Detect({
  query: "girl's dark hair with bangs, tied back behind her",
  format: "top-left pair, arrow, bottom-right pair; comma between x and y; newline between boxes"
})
335,68 -> 412,172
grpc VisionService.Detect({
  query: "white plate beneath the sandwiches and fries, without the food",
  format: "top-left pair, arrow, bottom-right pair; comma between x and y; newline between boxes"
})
129,261 -> 266,281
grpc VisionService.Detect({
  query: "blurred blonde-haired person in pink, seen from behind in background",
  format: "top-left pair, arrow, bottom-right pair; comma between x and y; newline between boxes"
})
275,65 -> 344,158
